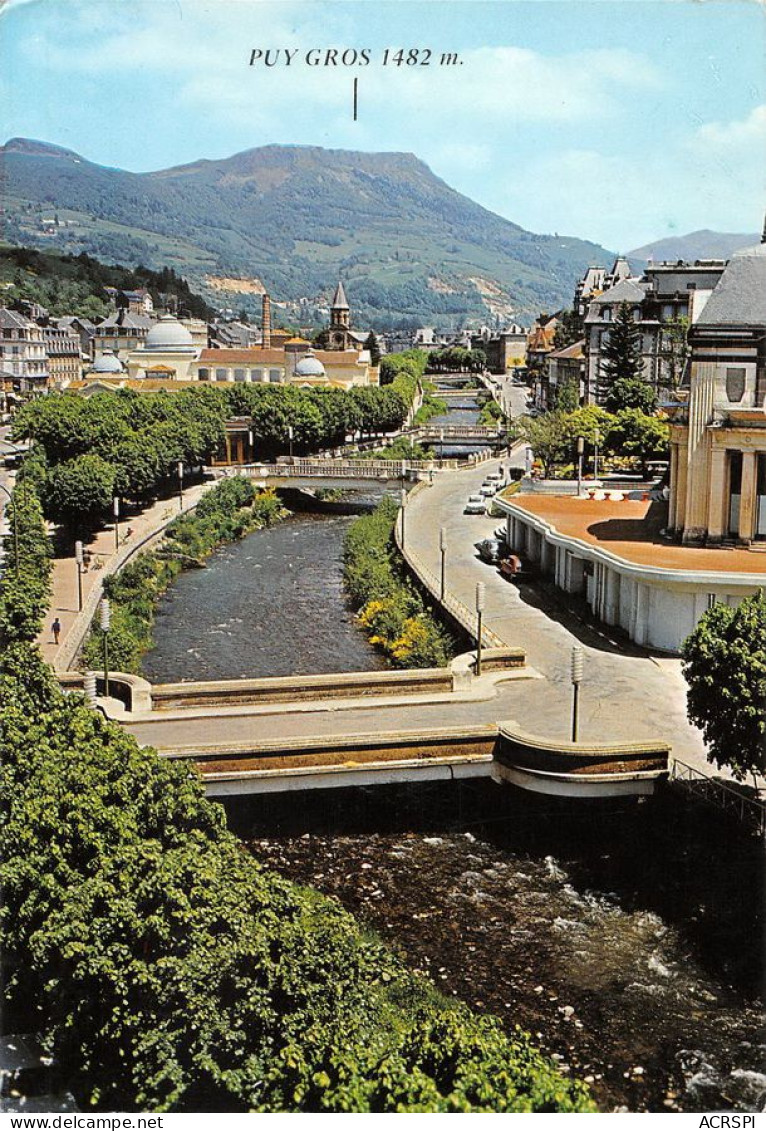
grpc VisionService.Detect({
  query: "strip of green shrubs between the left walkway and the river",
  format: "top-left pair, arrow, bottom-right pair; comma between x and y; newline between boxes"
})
83,476 -> 286,672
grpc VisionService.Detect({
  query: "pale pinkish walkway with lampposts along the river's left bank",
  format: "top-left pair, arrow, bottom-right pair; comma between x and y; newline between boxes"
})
37,480 -> 217,671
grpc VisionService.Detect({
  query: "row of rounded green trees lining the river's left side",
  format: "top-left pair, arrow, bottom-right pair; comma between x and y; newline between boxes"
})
14,368 -> 419,528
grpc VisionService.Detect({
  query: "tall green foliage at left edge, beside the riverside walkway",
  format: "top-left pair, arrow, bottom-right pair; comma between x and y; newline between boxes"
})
0,483 -> 51,644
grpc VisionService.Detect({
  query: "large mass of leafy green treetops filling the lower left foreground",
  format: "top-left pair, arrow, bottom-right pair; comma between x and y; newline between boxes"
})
0,645 -> 592,1112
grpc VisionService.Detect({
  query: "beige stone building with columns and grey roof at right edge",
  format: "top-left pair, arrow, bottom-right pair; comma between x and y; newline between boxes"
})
669,228 -> 766,545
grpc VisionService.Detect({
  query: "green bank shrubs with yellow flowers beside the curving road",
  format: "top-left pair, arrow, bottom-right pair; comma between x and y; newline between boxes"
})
343,499 -> 453,667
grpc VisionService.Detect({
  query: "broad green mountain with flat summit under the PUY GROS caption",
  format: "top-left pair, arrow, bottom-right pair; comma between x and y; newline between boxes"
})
0,138 -> 612,328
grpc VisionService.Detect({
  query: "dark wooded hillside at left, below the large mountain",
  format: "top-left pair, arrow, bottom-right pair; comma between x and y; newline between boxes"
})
0,245 -> 212,320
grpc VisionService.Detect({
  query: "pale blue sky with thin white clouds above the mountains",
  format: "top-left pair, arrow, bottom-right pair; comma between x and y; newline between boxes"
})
0,0 -> 766,251
